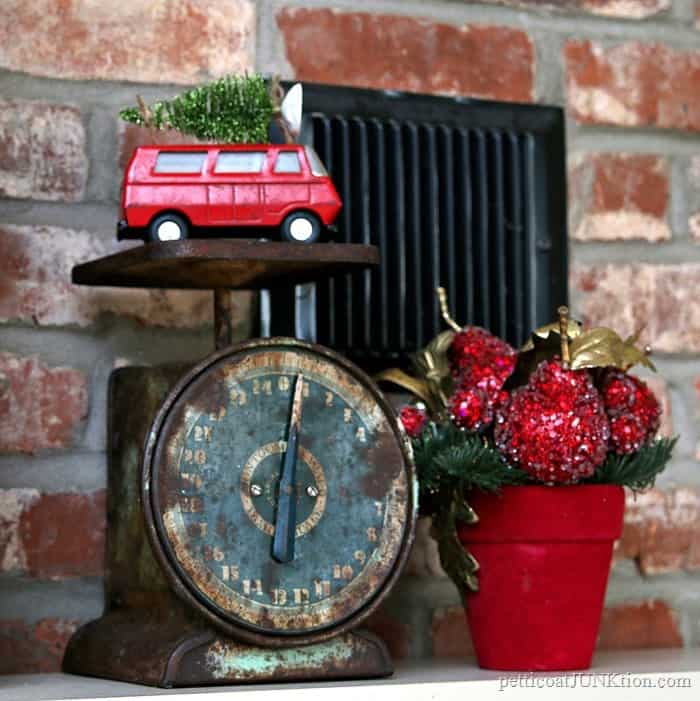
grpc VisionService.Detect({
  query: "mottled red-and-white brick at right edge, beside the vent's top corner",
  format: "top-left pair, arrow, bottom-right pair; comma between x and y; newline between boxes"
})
564,40 -> 700,131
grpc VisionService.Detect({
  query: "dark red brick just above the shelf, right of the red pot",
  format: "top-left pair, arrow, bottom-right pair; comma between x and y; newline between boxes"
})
597,600 -> 683,650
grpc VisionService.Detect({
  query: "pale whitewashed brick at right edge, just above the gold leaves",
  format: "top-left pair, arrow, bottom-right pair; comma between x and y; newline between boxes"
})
571,263 -> 700,353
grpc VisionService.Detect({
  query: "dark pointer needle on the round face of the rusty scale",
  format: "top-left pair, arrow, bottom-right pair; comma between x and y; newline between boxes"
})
272,373 -> 304,562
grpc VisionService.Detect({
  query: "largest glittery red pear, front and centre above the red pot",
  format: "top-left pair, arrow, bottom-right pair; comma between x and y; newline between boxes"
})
494,359 -> 610,483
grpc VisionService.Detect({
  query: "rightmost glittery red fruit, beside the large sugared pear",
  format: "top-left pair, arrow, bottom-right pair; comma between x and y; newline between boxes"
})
601,369 -> 661,455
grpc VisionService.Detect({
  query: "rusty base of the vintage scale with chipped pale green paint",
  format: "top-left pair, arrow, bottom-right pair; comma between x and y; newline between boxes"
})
63,610 -> 394,688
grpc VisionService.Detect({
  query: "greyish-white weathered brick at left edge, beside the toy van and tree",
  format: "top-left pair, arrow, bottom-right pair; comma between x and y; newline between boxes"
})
0,98 -> 88,202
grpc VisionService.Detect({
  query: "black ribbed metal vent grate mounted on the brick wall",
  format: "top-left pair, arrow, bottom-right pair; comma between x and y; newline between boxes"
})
268,85 -> 567,369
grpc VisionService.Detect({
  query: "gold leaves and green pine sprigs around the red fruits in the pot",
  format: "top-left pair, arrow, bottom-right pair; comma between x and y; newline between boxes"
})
392,288 -> 676,594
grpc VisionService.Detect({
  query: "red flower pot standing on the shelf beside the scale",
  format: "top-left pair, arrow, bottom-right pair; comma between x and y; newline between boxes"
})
458,485 -> 625,671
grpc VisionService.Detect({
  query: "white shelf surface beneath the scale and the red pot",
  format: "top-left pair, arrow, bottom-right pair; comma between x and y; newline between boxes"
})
0,648 -> 700,701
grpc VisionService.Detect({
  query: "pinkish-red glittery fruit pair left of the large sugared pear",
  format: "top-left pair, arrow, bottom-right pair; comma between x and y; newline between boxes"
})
448,326 -> 516,431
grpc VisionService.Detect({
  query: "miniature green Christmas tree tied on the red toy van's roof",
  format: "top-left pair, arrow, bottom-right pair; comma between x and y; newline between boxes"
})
119,75 -> 274,144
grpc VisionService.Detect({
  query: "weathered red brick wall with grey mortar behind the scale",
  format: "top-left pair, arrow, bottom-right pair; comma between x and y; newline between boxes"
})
0,0 -> 700,672
